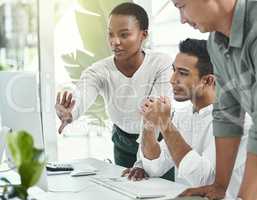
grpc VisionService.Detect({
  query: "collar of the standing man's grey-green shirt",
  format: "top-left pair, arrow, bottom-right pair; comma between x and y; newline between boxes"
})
215,0 -> 246,48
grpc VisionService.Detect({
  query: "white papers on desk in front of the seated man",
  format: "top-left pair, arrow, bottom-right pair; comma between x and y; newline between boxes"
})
90,176 -> 188,200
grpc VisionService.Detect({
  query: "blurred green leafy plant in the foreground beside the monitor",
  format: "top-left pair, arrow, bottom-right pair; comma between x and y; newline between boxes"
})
2,131 -> 45,200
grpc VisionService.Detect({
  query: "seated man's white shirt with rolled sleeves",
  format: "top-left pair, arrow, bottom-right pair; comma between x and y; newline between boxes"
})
140,105 -> 249,198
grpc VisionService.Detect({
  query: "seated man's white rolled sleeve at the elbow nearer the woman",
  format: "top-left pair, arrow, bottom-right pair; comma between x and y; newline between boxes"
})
140,142 -> 175,177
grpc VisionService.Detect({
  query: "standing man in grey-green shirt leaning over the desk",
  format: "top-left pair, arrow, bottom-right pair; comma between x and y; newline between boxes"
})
172,0 -> 257,200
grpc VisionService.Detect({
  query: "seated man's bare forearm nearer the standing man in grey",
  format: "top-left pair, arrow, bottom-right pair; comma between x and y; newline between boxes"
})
161,122 -> 192,167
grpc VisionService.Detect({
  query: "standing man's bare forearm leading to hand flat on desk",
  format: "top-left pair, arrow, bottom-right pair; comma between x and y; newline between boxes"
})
215,137 -> 241,189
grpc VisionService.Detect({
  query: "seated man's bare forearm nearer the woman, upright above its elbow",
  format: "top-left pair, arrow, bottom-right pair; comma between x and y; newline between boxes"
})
141,129 -> 161,160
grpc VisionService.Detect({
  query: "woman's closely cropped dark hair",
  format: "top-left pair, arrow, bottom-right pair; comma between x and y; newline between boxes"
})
110,3 -> 149,30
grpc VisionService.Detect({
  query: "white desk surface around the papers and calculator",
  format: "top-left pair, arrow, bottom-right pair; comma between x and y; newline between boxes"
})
26,158 -> 204,200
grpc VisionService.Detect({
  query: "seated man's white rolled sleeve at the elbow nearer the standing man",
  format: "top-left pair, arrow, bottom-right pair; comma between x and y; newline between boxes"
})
178,150 -> 215,187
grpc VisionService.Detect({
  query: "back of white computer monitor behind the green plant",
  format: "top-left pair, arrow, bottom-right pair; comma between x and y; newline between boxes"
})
0,71 -> 47,190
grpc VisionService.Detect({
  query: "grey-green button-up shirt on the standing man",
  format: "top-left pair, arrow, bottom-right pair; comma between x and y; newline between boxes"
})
208,0 -> 257,154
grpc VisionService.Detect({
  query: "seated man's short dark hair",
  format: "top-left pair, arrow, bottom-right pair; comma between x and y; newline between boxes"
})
179,38 -> 213,78
